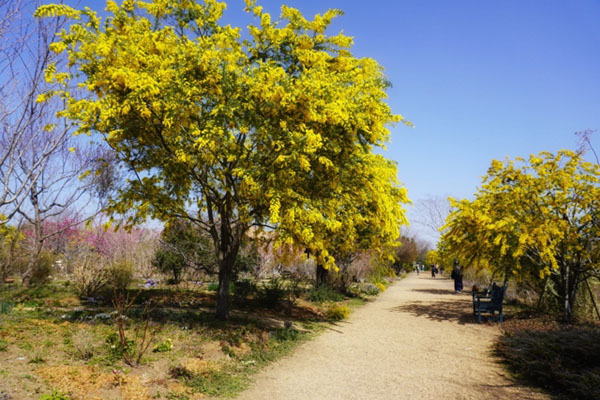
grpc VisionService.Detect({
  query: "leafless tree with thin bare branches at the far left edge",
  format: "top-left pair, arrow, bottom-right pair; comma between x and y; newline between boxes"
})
0,0 -> 113,280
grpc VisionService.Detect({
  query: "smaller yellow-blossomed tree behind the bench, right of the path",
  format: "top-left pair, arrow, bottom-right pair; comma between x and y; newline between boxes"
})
441,150 -> 600,320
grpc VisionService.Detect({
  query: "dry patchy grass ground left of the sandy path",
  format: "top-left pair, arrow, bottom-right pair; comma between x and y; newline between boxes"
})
0,276 -> 370,400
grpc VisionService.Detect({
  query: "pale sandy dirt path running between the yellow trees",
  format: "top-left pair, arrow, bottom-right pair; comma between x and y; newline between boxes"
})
238,273 -> 547,400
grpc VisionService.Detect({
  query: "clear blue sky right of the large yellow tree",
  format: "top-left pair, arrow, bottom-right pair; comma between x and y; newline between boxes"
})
219,0 -> 600,200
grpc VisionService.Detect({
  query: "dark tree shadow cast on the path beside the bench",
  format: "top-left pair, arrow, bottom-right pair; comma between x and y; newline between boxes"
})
390,300 -> 477,325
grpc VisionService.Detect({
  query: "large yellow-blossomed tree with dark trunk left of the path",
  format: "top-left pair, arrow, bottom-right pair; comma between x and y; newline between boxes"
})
37,0 -> 408,318
